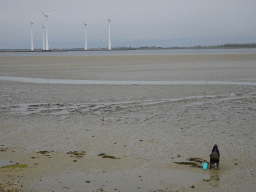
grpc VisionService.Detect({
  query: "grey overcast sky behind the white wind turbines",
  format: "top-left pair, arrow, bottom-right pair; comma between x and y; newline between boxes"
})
0,0 -> 256,49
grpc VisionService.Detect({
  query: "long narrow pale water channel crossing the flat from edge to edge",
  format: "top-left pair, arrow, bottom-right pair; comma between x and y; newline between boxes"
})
0,76 -> 256,85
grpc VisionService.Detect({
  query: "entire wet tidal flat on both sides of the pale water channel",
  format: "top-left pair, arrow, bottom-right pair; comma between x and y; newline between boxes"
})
0,54 -> 256,191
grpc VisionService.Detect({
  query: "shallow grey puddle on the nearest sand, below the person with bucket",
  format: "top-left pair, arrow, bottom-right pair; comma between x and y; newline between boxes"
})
29,168 -> 205,192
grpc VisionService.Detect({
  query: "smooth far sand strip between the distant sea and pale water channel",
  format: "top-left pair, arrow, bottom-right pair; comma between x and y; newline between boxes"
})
0,54 -> 256,81
